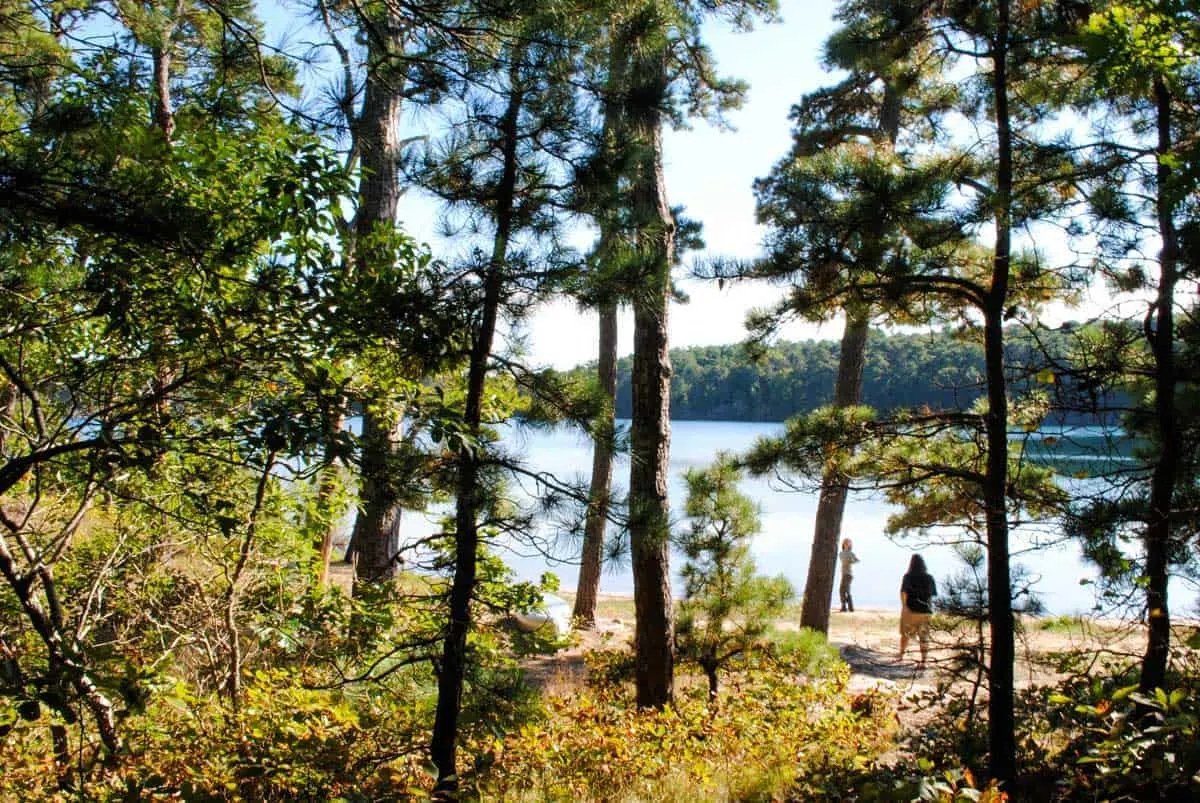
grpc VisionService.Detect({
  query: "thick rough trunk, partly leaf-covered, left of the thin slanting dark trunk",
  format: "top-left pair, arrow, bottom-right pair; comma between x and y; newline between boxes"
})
347,12 -> 403,583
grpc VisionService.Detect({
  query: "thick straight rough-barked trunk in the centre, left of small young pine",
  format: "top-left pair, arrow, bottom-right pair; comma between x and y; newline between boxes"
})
628,39 -> 674,708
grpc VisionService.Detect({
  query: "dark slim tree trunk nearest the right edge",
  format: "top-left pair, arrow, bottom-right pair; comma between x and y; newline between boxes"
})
1138,77 -> 1181,693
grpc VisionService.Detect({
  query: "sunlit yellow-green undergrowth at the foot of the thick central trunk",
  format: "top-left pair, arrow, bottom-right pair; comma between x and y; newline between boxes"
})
472,653 -> 892,801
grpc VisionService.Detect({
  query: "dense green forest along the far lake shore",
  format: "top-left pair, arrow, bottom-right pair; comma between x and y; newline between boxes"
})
576,324 -> 1108,425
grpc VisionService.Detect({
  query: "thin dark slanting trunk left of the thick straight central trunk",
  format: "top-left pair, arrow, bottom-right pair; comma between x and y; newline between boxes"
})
430,50 -> 524,799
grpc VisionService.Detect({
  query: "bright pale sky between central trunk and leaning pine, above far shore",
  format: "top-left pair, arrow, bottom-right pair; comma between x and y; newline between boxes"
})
516,0 -> 841,368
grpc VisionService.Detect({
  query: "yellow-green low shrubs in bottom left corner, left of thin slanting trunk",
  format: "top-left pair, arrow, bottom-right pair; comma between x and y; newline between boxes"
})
0,670 -> 427,801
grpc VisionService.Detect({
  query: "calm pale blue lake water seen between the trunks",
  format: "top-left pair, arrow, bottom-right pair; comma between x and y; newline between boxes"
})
403,421 -> 1195,613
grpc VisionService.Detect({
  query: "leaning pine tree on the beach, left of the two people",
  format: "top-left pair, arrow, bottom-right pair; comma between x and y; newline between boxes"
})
750,0 -> 954,633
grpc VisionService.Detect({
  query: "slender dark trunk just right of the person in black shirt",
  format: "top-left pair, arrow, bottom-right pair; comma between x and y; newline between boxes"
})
983,0 -> 1016,793
